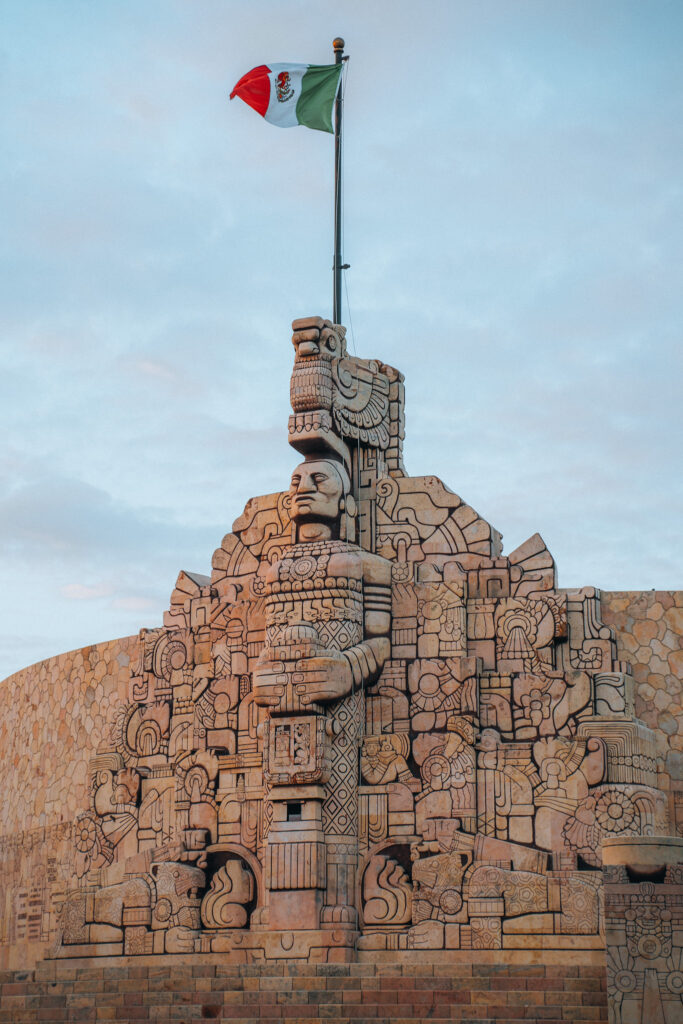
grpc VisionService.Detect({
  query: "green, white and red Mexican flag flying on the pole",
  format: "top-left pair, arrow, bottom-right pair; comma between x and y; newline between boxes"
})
230,63 -> 342,132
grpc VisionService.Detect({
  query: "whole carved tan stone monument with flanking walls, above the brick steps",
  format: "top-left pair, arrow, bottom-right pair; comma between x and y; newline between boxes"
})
0,317 -> 683,1024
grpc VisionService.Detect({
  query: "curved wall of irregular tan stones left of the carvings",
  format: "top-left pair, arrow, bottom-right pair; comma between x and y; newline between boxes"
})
0,637 -> 137,965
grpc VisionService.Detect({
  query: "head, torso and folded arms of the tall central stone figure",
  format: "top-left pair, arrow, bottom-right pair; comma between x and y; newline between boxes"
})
253,459 -> 391,711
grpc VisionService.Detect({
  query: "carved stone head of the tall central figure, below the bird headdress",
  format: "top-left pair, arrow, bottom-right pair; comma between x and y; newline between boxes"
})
290,459 -> 355,535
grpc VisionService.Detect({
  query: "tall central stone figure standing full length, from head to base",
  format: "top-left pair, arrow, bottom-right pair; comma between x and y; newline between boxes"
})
253,455 -> 391,929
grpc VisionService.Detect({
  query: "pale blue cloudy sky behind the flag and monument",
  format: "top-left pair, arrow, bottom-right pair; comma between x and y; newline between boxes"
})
0,0 -> 683,678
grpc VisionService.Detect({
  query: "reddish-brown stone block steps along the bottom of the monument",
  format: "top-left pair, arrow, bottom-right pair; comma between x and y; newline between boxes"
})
0,950 -> 607,1024
